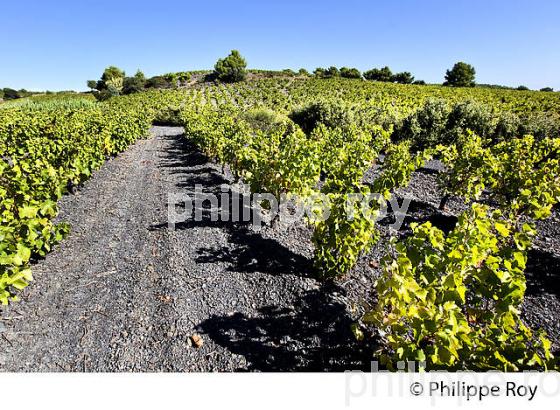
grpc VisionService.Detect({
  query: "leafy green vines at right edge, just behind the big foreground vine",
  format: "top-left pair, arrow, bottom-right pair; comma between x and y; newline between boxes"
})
440,132 -> 560,219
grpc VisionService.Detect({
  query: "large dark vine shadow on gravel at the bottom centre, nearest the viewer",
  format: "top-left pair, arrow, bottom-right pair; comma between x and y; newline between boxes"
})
199,286 -> 373,372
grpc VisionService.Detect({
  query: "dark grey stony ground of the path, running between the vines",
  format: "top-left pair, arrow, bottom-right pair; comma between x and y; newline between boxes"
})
0,127 -> 560,371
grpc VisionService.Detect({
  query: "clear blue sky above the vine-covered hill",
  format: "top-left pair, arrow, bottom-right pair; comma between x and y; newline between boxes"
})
0,0 -> 560,90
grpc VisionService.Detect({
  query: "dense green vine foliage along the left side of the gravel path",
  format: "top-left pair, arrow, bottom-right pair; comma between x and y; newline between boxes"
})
0,99 -> 151,304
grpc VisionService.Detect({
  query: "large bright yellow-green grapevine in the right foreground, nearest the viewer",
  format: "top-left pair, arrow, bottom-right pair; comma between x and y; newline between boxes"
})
363,205 -> 554,371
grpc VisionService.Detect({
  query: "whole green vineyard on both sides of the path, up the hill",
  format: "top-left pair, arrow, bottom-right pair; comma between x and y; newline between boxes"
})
0,77 -> 560,371
